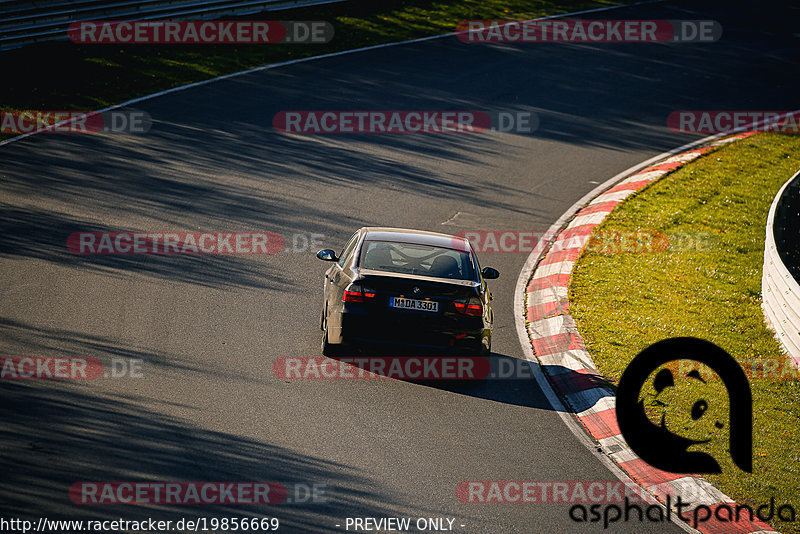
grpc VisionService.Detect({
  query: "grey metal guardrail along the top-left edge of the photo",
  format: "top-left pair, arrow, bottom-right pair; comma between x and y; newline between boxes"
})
0,0 -> 344,51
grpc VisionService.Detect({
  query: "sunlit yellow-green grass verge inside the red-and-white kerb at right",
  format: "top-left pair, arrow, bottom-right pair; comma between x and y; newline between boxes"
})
569,134 -> 800,533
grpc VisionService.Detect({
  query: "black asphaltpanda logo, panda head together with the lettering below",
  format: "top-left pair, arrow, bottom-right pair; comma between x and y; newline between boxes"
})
569,337 -> 797,532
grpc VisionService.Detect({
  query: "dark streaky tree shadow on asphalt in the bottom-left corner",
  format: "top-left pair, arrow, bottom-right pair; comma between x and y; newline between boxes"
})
0,381 -> 438,532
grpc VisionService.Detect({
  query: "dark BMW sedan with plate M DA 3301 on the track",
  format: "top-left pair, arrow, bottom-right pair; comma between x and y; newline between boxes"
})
317,228 -> 500,356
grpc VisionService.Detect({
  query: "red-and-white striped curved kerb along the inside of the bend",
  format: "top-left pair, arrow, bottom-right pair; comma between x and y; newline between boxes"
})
514,117 -> 796,534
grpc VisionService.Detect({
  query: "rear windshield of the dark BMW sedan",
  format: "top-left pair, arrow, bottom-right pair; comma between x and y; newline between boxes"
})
359,241 -> 475,280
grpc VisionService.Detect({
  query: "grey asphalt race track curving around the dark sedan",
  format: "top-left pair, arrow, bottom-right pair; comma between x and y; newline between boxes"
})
0,1 -> 800,533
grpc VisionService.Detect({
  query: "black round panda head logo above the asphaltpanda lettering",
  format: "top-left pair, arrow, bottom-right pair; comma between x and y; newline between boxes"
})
616,337 -> 753,473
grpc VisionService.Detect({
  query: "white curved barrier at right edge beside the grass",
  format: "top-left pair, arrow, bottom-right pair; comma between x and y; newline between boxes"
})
761,171 -> 800,367
